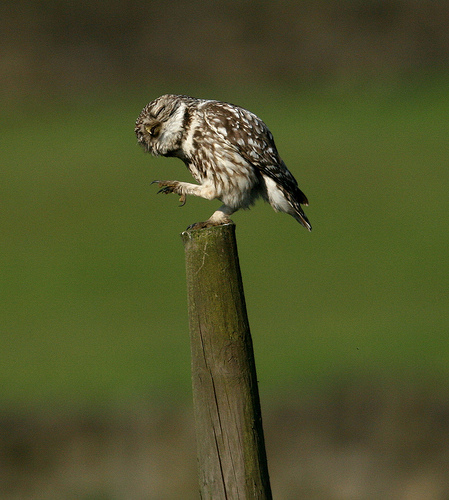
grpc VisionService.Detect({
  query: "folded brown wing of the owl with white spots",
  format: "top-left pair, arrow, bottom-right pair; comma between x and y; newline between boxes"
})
204,101 -> 308,205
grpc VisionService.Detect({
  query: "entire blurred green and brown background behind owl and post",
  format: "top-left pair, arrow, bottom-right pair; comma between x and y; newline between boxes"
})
0,0 -> 449,499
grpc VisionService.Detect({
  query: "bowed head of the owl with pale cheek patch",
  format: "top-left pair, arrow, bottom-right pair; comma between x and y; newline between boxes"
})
135,94 -> 189,156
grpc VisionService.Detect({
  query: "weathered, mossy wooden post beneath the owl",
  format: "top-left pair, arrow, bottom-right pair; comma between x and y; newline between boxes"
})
182,224 -> 272,500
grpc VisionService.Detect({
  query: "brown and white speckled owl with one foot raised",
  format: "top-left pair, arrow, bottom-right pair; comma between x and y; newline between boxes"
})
135,95 -> 312,231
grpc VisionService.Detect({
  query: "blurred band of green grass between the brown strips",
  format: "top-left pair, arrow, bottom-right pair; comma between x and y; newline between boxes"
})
0,75 -> 449,405
